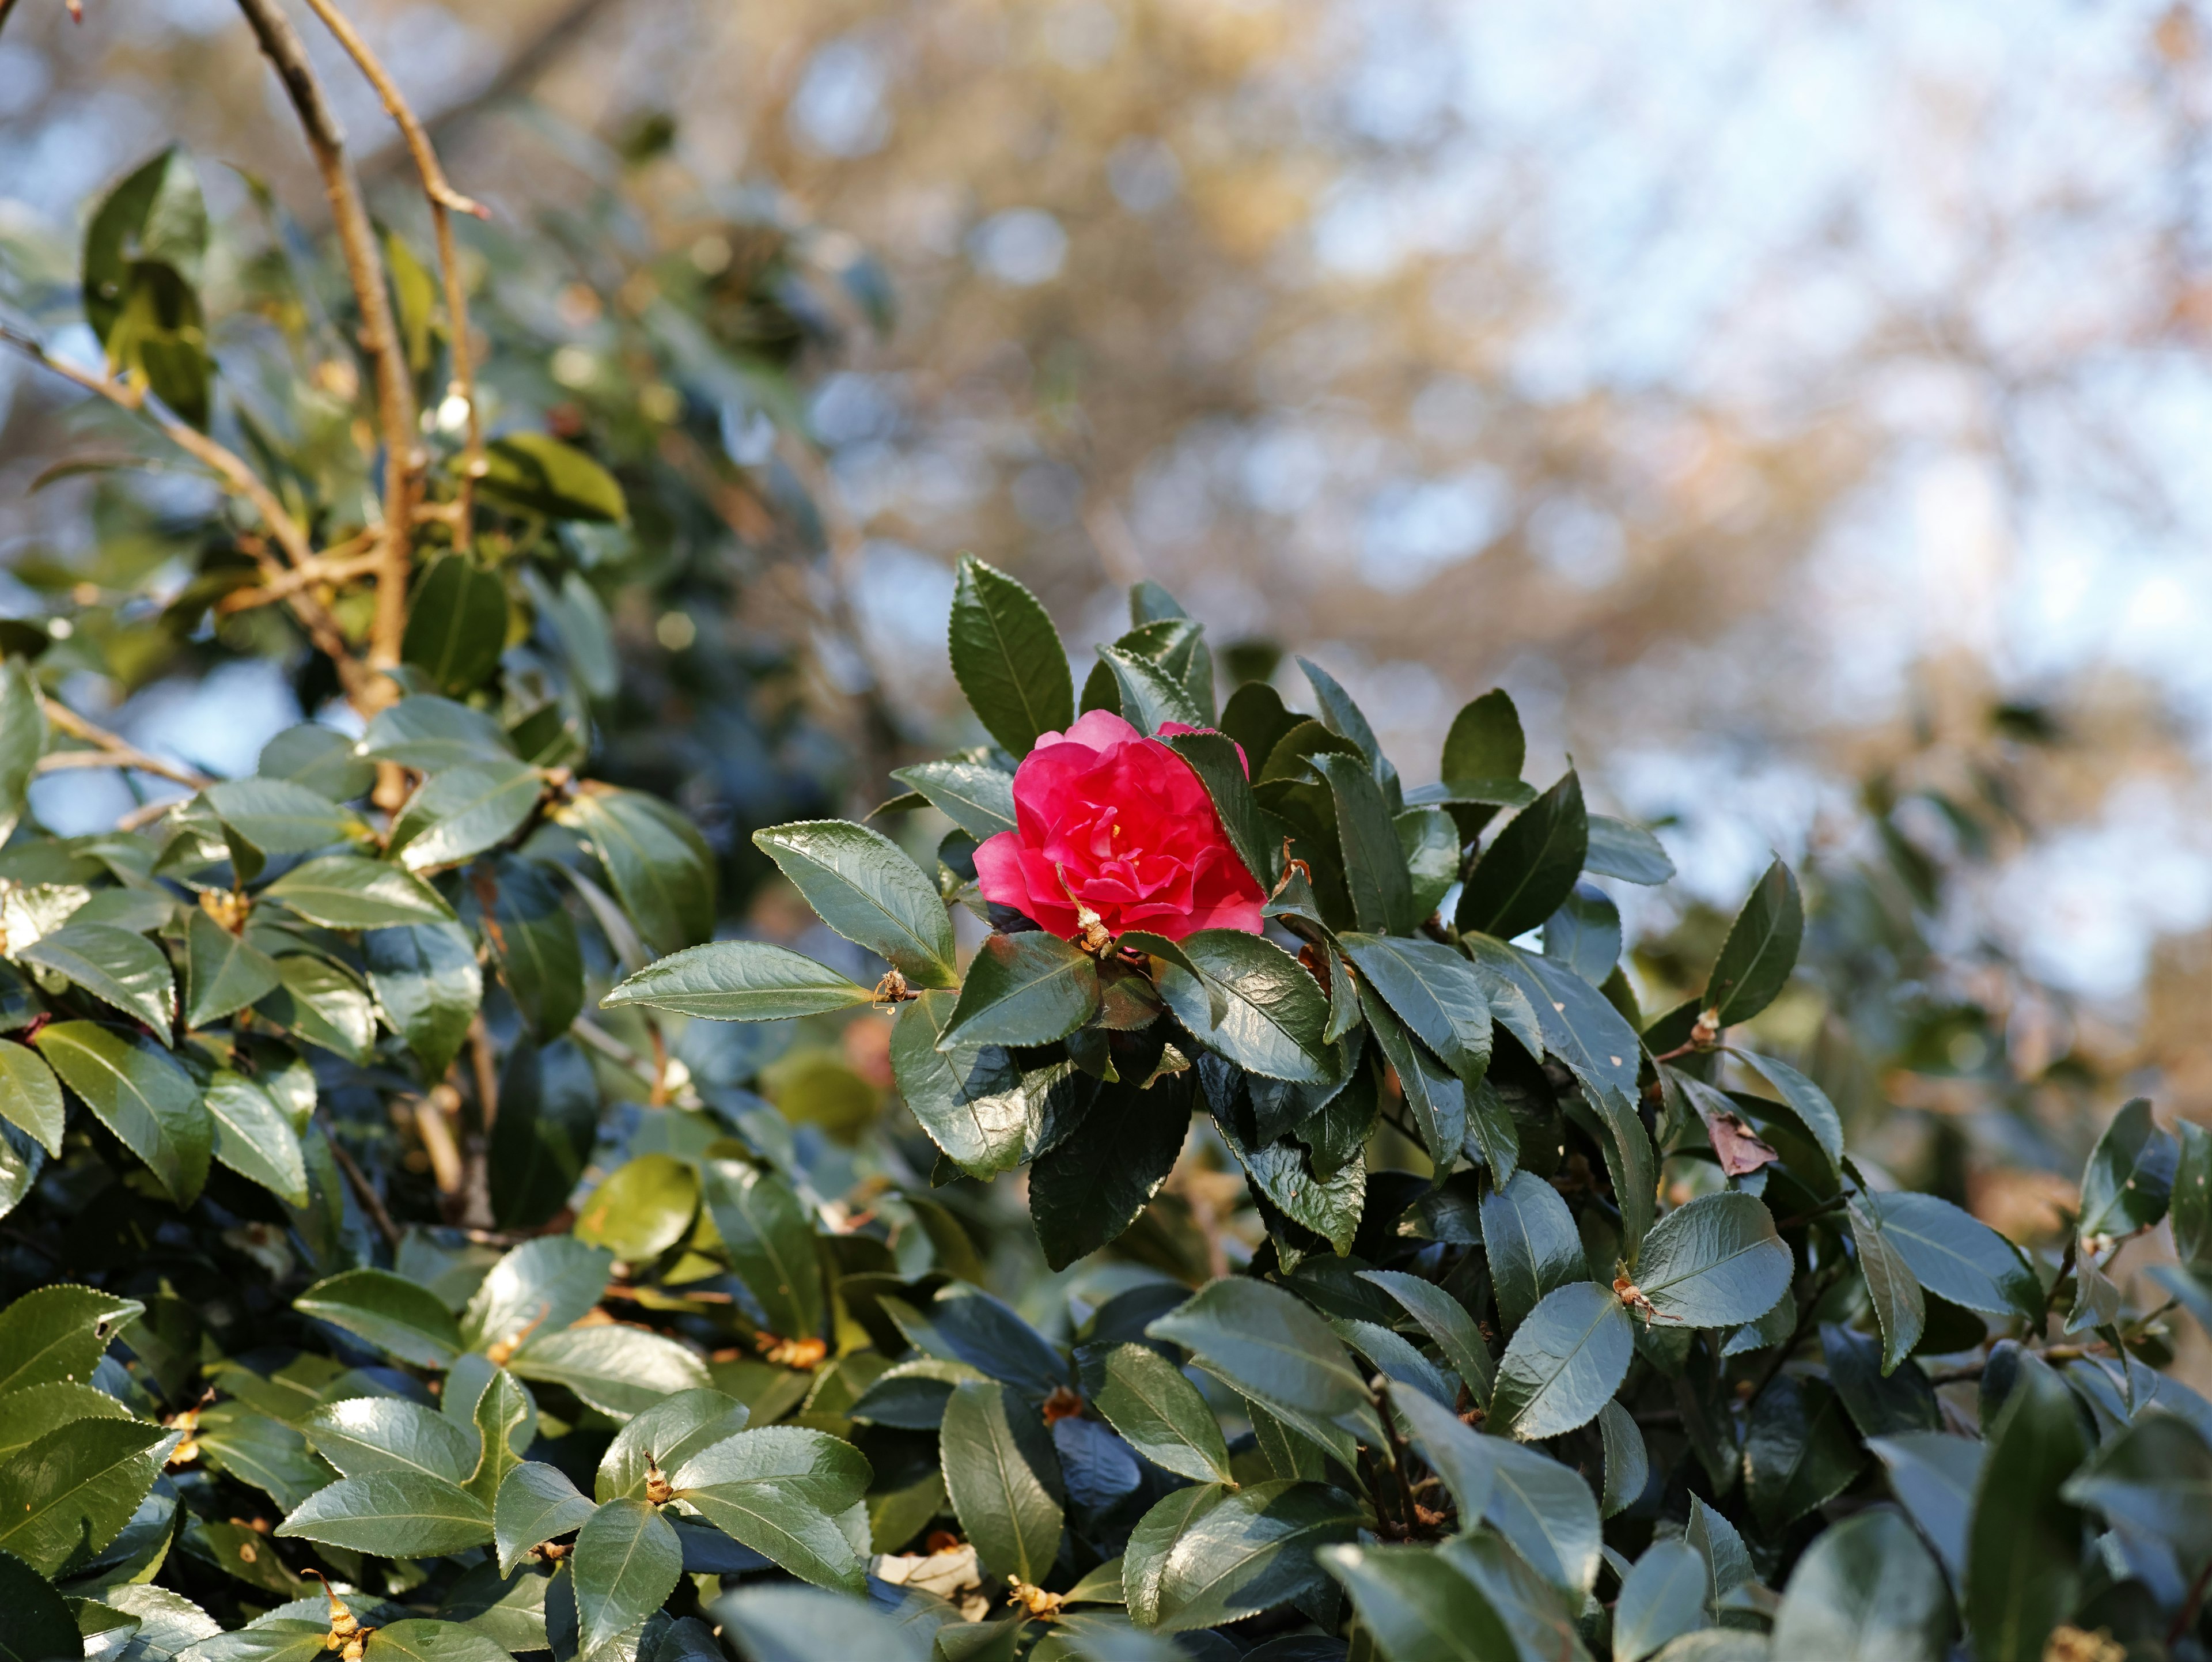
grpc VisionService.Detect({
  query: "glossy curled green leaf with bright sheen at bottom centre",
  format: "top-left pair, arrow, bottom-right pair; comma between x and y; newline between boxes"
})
1153,1478 -> 1361,1633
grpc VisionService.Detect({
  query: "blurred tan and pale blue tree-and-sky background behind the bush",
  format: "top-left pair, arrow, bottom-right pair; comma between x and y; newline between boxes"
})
0,0 -> 2212,1237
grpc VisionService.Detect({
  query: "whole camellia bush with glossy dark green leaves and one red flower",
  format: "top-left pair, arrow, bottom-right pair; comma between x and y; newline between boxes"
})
0,0 -> 2212,1662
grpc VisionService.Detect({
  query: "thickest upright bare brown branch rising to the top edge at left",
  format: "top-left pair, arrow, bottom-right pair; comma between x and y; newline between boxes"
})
239,0 -> 425,690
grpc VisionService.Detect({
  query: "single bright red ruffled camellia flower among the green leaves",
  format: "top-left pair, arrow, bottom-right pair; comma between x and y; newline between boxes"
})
975,710 -> 1265,941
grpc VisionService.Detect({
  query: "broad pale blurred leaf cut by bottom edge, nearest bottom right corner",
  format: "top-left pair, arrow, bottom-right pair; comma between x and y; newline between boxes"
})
1774,1509 -> 1951,1662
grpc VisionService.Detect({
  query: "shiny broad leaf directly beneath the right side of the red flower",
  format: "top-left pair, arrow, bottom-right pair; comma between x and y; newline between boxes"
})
1159,929 -> 1336,1084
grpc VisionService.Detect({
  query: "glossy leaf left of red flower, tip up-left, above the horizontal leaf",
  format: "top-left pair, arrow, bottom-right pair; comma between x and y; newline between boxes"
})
752,819 -> 960,987
